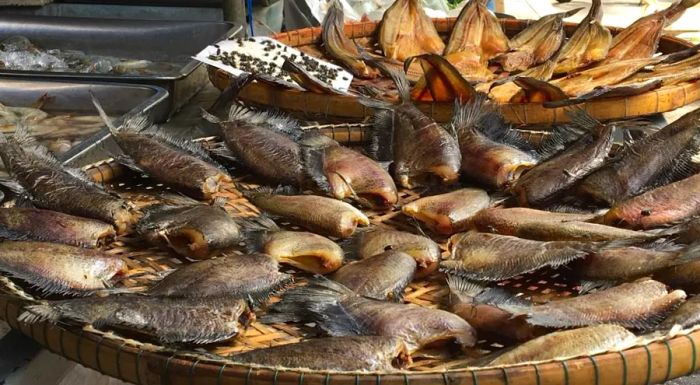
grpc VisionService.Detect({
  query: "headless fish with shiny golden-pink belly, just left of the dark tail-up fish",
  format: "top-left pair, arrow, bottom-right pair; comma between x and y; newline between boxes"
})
302,132 -> 399,209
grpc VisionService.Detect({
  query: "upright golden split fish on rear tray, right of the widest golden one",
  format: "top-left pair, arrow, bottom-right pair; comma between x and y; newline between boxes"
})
444,0 -> 509,60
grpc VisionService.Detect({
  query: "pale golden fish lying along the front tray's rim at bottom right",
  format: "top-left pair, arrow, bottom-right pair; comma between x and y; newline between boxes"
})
489,324 -> 637,366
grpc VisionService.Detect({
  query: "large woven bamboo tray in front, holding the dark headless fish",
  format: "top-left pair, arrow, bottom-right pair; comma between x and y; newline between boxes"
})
0,125 -> 700,385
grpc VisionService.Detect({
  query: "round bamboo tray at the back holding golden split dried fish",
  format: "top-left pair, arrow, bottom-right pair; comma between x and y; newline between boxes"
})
209,18 -> 700,125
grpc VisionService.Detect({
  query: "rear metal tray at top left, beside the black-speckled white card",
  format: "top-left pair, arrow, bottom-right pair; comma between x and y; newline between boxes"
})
0,15 -> 236,112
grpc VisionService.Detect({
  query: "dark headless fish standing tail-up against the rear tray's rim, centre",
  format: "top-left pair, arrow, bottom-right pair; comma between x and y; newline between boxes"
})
359,60 -> 462,188
